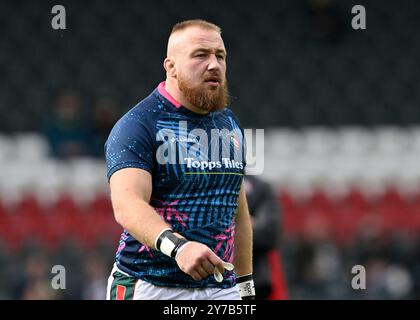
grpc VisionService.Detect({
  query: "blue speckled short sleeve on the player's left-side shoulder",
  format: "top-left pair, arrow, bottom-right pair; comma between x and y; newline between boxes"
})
105,113 -> 155,180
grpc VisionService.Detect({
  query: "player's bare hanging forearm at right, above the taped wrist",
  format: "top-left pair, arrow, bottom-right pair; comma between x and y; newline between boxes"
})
234,183 -> 252,276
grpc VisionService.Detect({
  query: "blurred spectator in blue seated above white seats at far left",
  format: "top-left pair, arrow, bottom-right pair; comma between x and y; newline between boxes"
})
43,91 -> 89,158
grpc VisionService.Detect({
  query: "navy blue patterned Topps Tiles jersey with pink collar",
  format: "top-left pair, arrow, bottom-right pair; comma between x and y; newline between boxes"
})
105,82 -> 245,288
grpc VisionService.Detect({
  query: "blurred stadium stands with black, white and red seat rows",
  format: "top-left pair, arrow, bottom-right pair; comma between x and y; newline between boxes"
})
0,0 -> 420,299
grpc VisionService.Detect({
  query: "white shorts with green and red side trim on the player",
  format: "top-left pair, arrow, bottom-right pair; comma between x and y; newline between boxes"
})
106,265 -> 241,300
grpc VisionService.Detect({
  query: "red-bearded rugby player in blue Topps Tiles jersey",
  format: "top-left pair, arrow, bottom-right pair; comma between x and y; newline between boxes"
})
105,20 -> 255,300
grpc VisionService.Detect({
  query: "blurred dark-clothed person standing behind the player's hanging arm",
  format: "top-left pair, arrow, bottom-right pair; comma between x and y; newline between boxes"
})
244,175 -> 285,299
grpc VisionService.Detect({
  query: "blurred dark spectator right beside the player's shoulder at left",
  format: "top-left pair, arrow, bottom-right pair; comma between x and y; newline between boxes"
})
91,98 -> 119,157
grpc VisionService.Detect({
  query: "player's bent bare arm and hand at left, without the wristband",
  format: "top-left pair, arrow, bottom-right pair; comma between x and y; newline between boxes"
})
110,168 -> 224,280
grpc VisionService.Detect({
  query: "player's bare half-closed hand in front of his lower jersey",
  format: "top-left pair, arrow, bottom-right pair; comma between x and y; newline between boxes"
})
175,241 -> 225,281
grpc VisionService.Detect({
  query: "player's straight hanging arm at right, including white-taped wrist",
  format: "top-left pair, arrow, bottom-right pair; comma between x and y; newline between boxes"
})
234,182 -> 255,299
